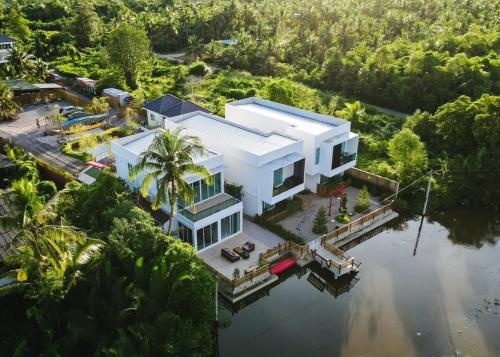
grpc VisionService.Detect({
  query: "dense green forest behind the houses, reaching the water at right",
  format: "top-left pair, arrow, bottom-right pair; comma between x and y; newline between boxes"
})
0,0 -> 500,205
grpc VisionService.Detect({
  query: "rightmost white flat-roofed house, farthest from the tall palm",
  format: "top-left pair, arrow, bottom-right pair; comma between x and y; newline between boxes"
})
225,97 -> 359,192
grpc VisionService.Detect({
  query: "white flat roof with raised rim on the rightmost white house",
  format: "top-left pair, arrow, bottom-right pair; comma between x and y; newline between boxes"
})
228,97 -> 348,135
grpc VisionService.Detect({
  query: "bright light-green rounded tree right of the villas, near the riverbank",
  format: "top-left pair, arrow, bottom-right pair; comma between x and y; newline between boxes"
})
388,128 -> 427,183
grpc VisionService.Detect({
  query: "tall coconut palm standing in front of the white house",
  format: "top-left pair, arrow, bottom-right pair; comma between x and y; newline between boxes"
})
130,128 -> 211,234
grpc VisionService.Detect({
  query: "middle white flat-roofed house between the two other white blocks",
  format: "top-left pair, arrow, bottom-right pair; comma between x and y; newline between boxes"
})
164,111 -> 304,216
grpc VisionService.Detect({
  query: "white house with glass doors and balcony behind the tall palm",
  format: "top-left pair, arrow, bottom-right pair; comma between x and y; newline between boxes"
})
111,129 -> 243,252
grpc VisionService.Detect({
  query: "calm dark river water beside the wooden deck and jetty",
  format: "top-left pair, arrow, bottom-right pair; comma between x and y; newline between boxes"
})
219,209 -> 500,357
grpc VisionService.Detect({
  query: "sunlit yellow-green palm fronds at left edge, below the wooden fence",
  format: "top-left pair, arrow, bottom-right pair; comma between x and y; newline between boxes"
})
0,184 -> 104,295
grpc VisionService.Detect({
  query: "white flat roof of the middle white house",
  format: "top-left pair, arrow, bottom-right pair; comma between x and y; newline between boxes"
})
173,112 -> 297,155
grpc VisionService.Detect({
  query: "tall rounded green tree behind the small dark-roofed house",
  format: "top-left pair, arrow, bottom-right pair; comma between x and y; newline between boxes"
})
106,23 -> 151,89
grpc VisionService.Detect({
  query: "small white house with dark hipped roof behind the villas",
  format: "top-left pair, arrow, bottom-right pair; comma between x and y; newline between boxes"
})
144,94 -> 210,127
